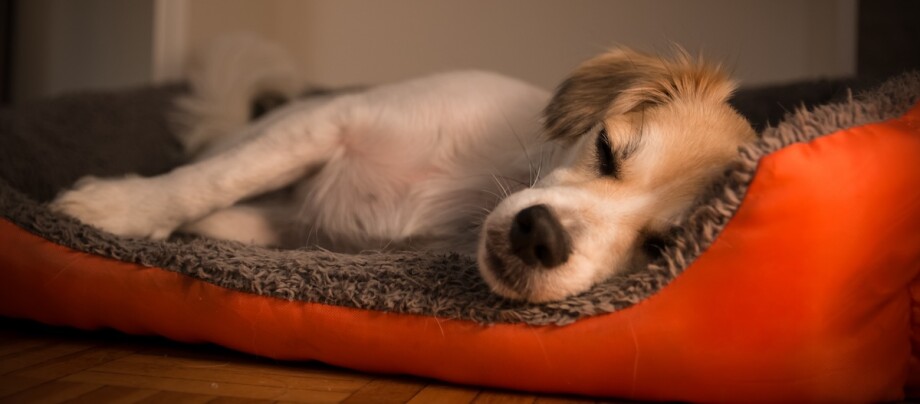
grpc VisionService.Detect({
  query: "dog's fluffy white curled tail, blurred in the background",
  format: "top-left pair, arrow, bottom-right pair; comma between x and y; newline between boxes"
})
176,34 -> 303,154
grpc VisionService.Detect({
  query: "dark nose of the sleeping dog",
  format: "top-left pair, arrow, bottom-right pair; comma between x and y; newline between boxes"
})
510,205 -> 571,268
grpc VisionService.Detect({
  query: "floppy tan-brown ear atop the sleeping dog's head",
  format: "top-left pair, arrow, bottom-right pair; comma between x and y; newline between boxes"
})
543,48 -> 734,139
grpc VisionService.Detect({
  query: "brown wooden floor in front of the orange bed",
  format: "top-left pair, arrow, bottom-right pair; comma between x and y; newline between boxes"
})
0,318 -> 620,404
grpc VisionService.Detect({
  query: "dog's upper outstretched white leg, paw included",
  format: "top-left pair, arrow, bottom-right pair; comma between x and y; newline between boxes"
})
51,114 -> 340,239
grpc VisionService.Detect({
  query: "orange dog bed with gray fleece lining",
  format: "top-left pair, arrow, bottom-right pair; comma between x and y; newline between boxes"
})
0,73 -> 920,401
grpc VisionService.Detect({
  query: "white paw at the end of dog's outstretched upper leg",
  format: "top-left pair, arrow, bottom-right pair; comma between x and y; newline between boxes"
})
50,175 -> 181,239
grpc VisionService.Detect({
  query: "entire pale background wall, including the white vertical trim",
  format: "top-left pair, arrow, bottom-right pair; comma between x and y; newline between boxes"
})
17,0 -> 856,101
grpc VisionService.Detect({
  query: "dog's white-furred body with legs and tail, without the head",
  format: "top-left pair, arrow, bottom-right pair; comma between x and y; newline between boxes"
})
53,38 -> 549,253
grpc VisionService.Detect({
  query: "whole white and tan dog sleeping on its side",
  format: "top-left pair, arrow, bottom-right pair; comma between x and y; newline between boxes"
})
51,37 -> 755,302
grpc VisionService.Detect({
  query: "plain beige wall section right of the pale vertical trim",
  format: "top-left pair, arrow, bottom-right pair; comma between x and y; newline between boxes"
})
188,0 -> 856,87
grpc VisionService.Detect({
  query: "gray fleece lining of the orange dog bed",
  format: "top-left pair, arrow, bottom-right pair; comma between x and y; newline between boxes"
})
0,72 -> 920,325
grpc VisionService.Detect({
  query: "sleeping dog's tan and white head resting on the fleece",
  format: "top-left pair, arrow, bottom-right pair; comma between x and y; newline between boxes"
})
478,49 -> 755,302
